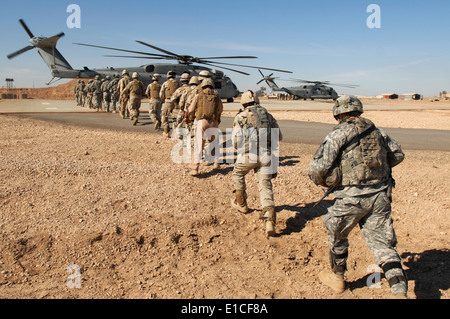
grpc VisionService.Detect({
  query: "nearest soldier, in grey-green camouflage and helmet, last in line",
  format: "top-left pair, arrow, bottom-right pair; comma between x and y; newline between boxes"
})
308,96 -> 408,298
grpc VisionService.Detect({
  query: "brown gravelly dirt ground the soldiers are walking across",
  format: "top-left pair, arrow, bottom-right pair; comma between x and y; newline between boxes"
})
0,107 -> 450,299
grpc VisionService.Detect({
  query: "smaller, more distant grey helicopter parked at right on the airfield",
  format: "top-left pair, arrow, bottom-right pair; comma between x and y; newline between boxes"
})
257,70 -> 358,101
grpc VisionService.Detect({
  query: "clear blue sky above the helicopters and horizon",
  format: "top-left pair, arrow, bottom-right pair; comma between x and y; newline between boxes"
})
0,0 -> 450,96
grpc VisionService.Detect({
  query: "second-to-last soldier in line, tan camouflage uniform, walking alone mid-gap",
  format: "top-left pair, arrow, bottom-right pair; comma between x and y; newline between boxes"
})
231,91 -> 283,237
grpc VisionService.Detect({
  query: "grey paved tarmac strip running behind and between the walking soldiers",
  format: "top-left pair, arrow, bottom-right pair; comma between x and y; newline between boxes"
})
0,100 -> 450,151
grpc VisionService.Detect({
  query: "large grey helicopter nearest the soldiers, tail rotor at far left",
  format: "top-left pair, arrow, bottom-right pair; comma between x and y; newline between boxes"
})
7,19 -> 292,102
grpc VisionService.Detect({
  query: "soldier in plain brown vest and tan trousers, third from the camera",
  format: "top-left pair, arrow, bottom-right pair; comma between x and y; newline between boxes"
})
188,79 -> 223,176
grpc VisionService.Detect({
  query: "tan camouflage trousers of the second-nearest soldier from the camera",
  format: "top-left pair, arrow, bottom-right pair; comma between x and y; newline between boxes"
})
233,157 -> 275,208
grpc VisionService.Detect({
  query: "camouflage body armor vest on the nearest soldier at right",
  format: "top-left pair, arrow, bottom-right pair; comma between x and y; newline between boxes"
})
338,117 -> 390,186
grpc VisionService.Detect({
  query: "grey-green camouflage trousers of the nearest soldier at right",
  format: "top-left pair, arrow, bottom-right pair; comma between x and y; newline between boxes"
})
324,190 -> 401,272
